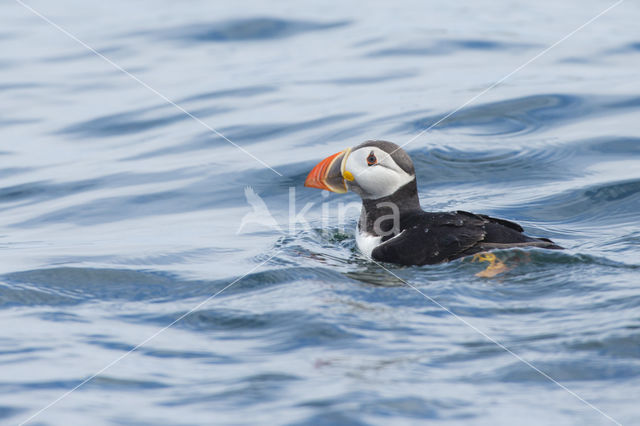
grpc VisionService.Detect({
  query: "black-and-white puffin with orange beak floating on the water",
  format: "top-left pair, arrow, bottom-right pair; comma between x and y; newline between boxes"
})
304,140 -> 562,266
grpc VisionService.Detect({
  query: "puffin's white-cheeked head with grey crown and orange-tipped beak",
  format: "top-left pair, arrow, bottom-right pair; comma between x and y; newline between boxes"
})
304,141 -> 416,200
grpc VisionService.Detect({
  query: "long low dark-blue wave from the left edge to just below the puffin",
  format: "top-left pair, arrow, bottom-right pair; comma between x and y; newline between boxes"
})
0,259 -> 350,308
